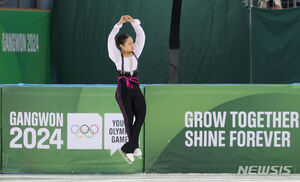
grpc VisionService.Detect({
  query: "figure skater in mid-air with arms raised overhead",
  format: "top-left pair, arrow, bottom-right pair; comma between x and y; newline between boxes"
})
107,15 -> 146,164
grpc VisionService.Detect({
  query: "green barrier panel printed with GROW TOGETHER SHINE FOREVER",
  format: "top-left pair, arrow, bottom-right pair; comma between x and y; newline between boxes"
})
145,85 -> 300,174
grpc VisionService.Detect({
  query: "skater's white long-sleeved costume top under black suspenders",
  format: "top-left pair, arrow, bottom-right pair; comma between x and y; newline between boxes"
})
107,19 -> 145,75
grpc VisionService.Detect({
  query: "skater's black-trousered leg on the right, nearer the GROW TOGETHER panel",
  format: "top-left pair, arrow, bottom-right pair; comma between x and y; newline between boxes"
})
131,88 -> 146,149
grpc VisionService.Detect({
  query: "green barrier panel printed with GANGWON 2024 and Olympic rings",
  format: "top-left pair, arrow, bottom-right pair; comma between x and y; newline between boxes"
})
2,86 -> 144,173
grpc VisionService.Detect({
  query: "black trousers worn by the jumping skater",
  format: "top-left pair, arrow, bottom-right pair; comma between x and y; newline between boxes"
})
116,79 -> 146,153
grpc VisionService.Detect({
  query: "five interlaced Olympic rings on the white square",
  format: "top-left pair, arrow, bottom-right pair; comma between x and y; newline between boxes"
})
71,124 -> 99,138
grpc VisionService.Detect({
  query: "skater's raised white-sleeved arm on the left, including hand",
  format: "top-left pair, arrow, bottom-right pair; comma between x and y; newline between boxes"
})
107,16 -> 127,62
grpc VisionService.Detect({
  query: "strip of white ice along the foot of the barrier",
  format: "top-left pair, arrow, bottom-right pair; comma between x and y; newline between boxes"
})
0,173 -> 300,182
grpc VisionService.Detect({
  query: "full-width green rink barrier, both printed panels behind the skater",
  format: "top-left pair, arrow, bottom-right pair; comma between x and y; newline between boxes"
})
0,84 -> 300,174
